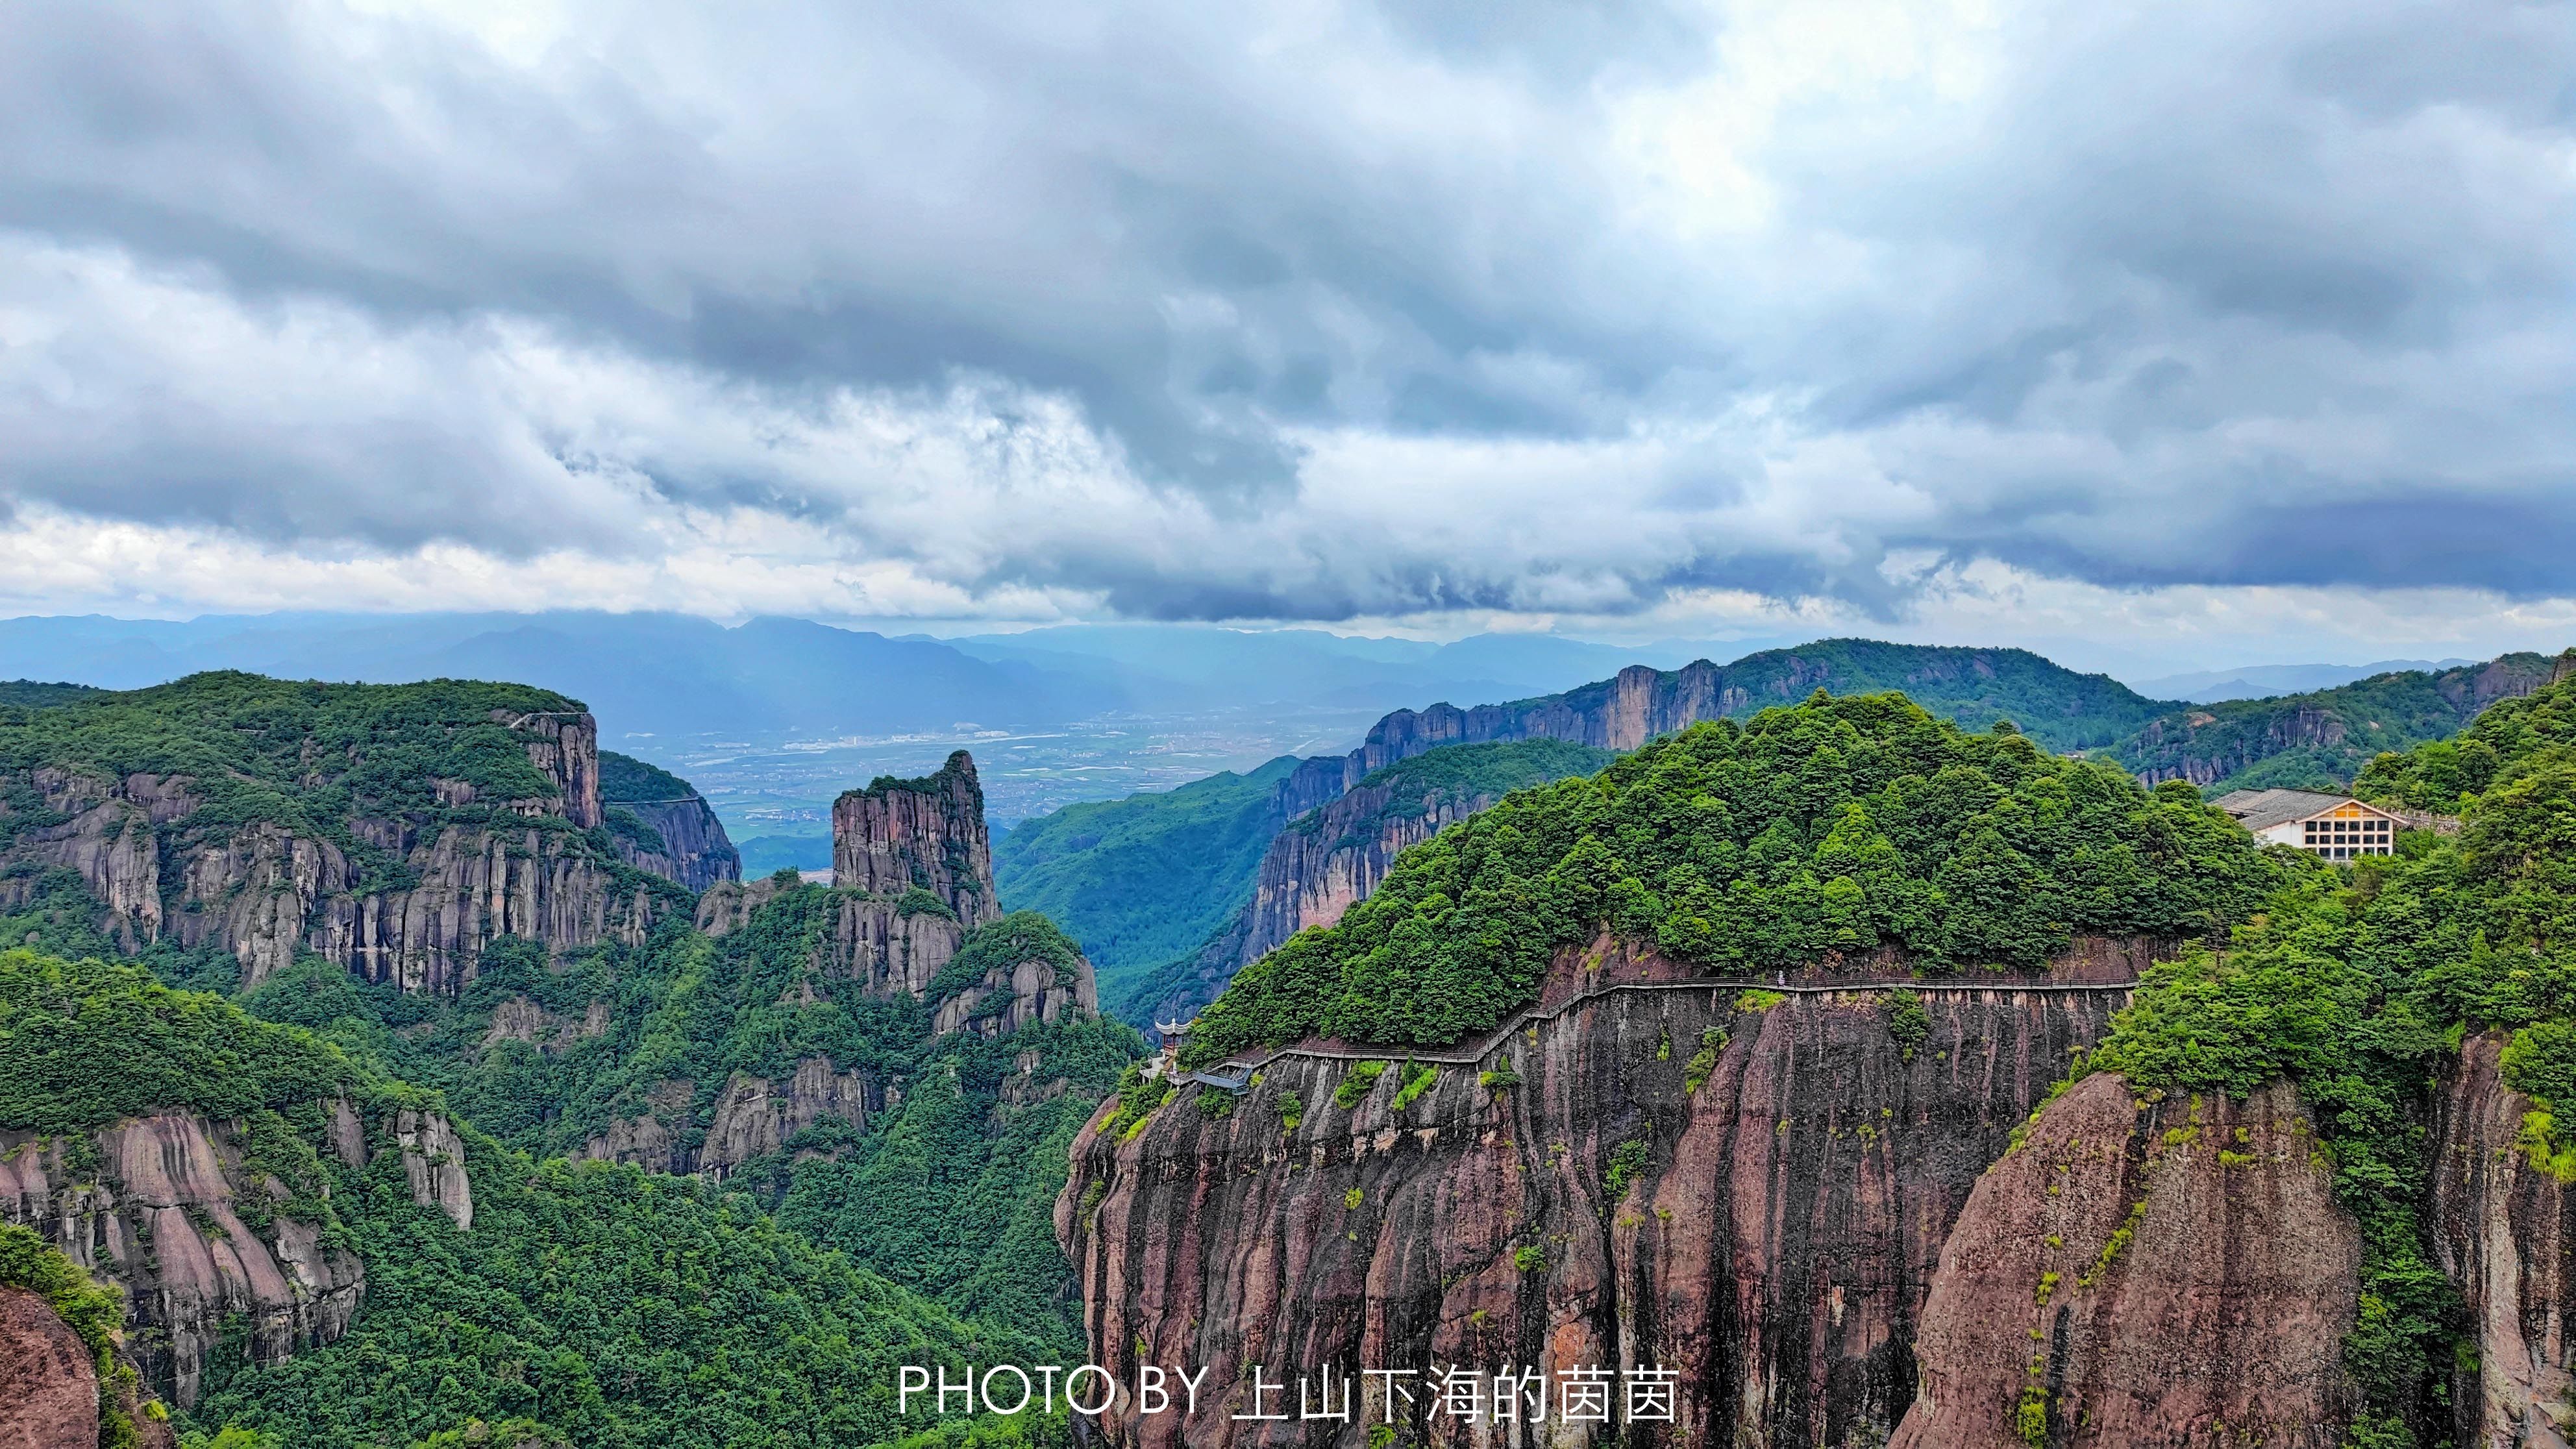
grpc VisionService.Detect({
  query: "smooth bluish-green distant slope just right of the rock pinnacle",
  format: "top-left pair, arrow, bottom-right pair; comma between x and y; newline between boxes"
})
992,756 -> 1298,990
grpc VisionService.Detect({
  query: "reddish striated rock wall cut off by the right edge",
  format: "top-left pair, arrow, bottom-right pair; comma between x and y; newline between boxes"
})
2432,1032 -> 2576,1449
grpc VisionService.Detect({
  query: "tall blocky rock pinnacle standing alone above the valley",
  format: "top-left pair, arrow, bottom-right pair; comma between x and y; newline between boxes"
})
832,750 -> 1002,926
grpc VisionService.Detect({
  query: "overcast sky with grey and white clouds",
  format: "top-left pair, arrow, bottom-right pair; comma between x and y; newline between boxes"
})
0,0 -> 2576,668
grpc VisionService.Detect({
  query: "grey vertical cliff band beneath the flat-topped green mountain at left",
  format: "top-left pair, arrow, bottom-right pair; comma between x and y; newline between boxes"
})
0,714 -> 673,993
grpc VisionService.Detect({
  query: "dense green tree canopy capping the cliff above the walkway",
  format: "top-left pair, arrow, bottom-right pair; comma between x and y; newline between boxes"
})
1187,691 -> 2277,1065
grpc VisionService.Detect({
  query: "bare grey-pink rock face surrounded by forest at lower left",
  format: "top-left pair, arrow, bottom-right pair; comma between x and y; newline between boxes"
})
0,1104 -> 474,1407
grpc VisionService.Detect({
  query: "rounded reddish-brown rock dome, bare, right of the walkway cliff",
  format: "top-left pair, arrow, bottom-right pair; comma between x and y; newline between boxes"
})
1891,1075 -> 2362,1449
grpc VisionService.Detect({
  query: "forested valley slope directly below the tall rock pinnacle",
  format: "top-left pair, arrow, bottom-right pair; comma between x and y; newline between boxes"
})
245,884 -> 1141,1309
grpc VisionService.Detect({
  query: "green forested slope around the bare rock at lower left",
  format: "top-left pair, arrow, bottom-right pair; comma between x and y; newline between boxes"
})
0,951 -> 1061,1449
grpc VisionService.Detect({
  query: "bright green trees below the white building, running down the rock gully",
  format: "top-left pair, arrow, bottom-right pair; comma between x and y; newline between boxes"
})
2079,678 -> 2576,1449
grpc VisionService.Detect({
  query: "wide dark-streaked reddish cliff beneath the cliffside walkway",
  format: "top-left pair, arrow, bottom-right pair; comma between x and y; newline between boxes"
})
1056,928 -> 2146,1446
